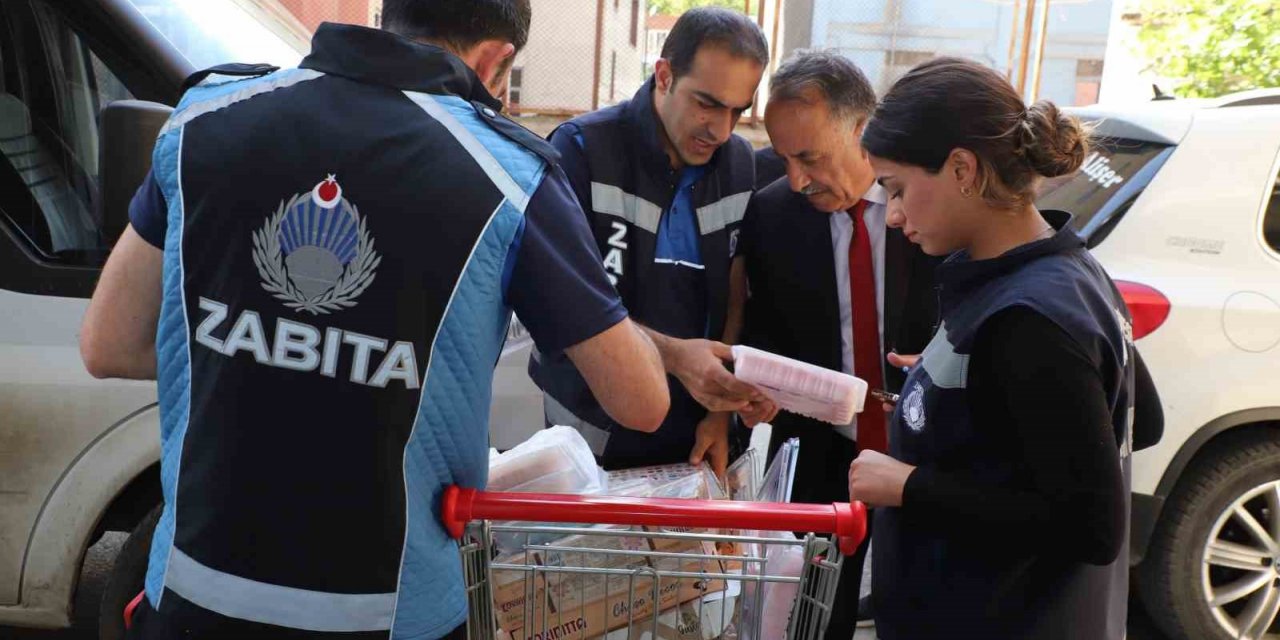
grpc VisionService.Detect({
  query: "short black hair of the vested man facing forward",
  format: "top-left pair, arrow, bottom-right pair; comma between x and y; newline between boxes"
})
662,6 -> 769,78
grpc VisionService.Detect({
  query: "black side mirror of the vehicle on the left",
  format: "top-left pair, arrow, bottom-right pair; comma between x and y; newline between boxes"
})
97,100 -> 173,246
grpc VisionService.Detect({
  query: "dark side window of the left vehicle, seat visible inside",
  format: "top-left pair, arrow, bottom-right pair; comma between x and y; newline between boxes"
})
0,0 -> 133,264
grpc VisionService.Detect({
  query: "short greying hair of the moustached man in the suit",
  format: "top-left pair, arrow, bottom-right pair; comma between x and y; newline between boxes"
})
769,49 -> 876,123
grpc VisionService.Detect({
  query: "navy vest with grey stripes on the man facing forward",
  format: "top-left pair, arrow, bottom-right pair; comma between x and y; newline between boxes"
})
529,78 -> 755,466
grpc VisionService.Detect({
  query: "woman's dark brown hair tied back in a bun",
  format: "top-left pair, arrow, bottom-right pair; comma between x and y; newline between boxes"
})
863,58 -> 1089,206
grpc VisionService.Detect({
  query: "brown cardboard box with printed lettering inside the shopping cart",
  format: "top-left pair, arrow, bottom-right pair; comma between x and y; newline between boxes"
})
493,531 -> 726,640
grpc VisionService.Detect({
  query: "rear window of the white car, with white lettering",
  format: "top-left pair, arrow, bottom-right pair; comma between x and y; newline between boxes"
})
1036,138 -> 1174,247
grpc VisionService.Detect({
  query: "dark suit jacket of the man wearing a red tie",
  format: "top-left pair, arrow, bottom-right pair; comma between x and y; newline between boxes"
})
739,178 -> 941,503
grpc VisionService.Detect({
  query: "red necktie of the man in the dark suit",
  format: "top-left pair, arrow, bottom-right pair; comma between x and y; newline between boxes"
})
849,200 -> 888,452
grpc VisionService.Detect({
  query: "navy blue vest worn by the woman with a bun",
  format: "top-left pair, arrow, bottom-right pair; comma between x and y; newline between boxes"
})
873,211 -> 1134,640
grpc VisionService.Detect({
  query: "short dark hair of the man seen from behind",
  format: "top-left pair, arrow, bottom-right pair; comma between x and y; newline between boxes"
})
383,0 -> 532,51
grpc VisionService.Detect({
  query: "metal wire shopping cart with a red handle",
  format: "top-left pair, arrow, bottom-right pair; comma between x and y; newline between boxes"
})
442,486 -> 867,640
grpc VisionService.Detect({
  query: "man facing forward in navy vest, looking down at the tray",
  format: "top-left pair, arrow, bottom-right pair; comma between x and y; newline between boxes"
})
529,8 -> 776,471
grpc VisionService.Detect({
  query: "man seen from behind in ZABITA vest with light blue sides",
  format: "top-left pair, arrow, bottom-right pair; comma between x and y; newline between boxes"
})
82,0 -> 668,639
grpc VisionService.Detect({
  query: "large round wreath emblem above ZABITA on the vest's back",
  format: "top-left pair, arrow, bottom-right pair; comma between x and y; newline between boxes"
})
253,175 -> 383,315
